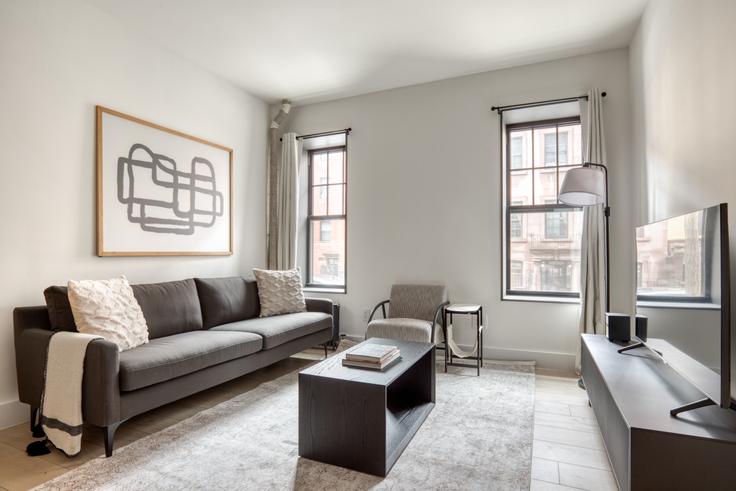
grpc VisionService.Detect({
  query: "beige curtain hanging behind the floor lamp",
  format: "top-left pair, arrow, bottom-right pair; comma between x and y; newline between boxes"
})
575,89 -> 608,373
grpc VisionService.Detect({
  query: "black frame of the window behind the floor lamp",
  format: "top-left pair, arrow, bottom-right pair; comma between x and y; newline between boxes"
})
501,116 -> 582,302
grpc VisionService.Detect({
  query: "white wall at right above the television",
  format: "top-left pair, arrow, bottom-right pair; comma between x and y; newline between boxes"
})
630,0 -> 736,225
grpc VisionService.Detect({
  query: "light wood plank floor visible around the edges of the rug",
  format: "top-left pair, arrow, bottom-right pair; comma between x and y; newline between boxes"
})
0,358 -> 617,491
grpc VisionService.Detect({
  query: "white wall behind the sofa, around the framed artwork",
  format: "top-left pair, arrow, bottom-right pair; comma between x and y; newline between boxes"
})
0,0 -> 268,427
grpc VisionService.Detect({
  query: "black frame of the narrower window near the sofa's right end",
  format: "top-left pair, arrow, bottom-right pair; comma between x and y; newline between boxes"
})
304,146 -> 348,293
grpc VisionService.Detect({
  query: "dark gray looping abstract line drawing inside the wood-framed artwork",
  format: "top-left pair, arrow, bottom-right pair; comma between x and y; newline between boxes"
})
117,143 -> 224,235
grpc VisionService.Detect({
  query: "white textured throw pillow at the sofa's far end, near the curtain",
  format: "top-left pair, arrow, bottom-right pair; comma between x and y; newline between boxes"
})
253,269 -> 307,317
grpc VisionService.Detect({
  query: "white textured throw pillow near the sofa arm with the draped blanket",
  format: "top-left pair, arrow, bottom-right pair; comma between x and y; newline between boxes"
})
67,276 -> 148,351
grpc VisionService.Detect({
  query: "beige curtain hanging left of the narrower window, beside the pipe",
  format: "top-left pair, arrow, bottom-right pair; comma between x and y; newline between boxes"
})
272,133 -> 301,269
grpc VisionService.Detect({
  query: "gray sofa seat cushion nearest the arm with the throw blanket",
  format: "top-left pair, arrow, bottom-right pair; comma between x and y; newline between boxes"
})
120,331 -> 263,391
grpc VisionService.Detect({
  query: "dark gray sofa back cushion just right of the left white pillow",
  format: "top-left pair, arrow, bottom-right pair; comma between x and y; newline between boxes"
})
132,279 -> 202,339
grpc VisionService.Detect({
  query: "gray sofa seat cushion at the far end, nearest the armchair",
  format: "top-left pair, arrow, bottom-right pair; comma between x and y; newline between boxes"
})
210,312 -> 332,349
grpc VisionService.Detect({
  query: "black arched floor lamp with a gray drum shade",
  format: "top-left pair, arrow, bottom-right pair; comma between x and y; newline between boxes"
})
560,162 -> 611,389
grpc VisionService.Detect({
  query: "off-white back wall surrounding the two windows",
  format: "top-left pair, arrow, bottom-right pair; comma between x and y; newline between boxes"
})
290,49 -> 633,370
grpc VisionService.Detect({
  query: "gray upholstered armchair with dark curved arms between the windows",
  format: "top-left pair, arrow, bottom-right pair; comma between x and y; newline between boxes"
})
365,285 -> 448,343
